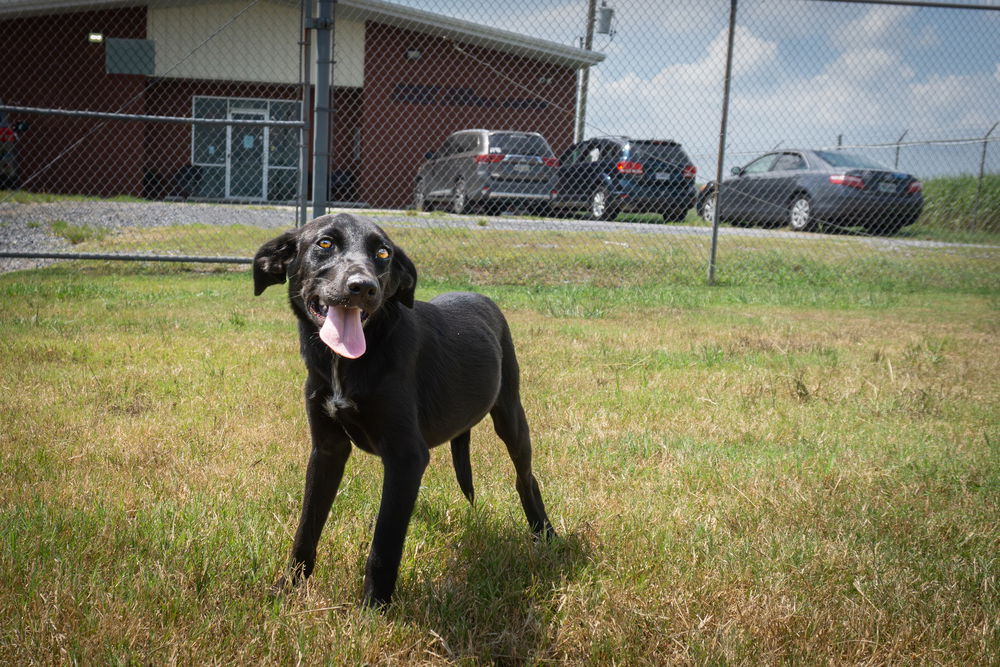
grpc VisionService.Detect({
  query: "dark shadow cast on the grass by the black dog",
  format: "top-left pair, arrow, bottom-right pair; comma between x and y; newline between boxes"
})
395,505 -> 592,664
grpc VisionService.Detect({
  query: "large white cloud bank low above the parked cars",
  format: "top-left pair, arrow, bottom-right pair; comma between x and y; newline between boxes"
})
588,18 -> 1000,168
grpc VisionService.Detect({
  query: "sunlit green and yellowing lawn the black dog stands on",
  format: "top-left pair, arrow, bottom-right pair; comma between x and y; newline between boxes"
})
0,264 -> 1000,665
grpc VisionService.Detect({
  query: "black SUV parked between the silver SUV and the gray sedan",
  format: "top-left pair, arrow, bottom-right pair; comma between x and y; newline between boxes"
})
549,137 -> 697,222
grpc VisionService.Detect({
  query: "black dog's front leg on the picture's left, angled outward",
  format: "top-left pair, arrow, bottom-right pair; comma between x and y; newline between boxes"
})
276,384 -> 351,589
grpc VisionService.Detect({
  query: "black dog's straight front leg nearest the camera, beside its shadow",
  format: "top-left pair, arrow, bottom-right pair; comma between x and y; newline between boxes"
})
362,442 -> 430,607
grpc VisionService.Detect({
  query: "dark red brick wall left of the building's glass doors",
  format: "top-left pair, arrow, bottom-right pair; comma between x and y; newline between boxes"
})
0,7 -> 146,195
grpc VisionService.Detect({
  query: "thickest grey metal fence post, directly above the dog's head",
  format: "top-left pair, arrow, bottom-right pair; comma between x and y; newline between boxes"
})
313,0 -> 336,218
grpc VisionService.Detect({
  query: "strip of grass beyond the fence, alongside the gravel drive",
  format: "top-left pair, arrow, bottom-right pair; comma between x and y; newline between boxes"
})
37,219 -> 1000,298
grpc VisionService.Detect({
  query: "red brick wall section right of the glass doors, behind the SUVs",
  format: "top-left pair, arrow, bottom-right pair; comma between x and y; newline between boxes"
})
360,21 -> 576,207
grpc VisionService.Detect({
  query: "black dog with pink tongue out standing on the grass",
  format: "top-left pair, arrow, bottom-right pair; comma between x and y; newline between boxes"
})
253,214 -> 554,606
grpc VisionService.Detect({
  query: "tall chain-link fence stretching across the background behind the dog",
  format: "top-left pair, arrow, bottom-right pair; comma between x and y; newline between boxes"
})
0,0 -> 1000,288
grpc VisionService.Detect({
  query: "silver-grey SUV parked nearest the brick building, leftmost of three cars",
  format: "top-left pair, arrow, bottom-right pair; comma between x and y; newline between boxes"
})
413,130 -> 559,213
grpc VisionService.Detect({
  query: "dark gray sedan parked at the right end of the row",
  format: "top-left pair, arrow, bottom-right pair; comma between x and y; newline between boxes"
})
697,150 -> 924,234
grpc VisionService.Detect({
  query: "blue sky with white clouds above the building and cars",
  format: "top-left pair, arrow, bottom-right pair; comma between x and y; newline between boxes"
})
386,0 -> 1000,180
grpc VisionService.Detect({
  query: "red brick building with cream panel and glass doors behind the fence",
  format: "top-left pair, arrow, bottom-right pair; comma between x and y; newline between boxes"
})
0,0 -> 603,207
